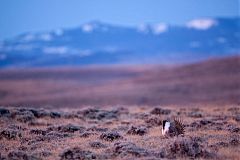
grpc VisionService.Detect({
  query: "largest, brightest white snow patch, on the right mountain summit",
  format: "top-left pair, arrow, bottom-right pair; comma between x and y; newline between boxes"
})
186,18 -> 217,30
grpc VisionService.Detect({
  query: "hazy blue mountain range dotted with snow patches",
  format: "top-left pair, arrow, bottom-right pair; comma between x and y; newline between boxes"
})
0,18 -> 240,67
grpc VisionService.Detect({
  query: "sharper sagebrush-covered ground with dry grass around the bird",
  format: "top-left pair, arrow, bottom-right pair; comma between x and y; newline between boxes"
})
0,105 -> 240,160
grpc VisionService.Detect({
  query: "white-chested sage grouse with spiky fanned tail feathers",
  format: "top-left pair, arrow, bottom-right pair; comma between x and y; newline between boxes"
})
162,118 -> 185,137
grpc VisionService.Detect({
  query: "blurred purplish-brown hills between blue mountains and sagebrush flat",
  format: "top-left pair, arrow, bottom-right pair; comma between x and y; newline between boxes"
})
0,56 -> 240,107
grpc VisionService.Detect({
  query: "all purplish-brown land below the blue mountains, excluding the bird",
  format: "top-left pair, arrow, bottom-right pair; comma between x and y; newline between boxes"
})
0,56 -> 240,160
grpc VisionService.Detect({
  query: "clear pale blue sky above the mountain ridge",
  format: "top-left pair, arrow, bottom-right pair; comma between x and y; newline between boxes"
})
0,0 -> 240,39
